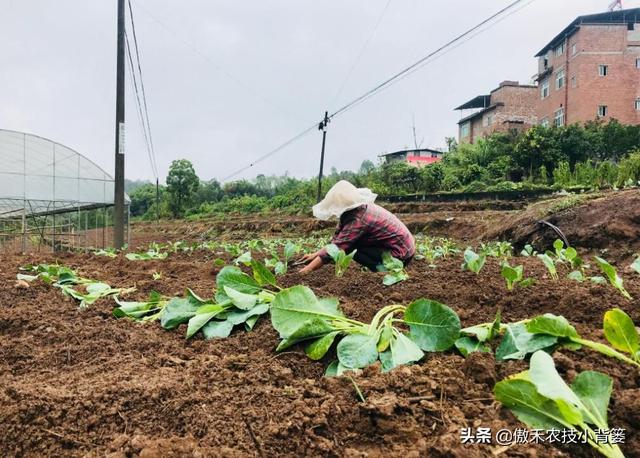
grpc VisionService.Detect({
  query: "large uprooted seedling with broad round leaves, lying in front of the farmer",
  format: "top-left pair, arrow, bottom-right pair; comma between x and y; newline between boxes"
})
271,286 -> 460,375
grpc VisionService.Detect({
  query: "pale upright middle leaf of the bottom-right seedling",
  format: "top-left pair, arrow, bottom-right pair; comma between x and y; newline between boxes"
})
529,351 -> 584,425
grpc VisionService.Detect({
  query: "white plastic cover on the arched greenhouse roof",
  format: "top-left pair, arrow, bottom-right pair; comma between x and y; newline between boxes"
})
0,129 -> 129,218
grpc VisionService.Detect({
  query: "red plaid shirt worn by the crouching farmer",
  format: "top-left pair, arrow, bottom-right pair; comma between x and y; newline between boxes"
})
319,204 -> 416,262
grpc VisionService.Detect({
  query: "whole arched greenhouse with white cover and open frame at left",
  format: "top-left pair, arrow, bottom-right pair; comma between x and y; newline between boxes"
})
0,129 -> 129,252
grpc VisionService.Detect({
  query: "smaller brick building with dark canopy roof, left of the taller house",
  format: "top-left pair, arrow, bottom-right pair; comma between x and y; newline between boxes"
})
456,81 -> 538,143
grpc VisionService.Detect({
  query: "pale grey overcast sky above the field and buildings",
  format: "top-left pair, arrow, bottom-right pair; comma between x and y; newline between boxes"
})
0,0 -> 640,181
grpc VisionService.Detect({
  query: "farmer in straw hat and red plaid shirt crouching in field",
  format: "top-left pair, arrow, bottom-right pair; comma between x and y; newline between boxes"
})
300,180 -> 416,274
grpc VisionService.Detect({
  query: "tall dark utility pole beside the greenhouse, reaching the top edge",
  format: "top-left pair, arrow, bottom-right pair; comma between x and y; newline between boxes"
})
113,0 -> 125,249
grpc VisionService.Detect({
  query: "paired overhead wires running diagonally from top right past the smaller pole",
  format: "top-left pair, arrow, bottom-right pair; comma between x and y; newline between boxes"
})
222,0 -> 535,182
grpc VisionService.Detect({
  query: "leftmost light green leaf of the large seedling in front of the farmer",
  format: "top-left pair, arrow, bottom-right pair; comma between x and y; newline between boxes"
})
271,285 -> 344,339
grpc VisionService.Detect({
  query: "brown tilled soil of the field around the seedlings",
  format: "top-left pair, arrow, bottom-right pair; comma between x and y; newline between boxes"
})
0,191 -> 640,457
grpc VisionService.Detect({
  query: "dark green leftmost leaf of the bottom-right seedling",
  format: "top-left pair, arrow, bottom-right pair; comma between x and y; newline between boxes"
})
493,377 -> 571,430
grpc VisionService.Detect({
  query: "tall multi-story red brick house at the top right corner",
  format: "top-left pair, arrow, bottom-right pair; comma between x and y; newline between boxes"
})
536,8 -> 640,126
